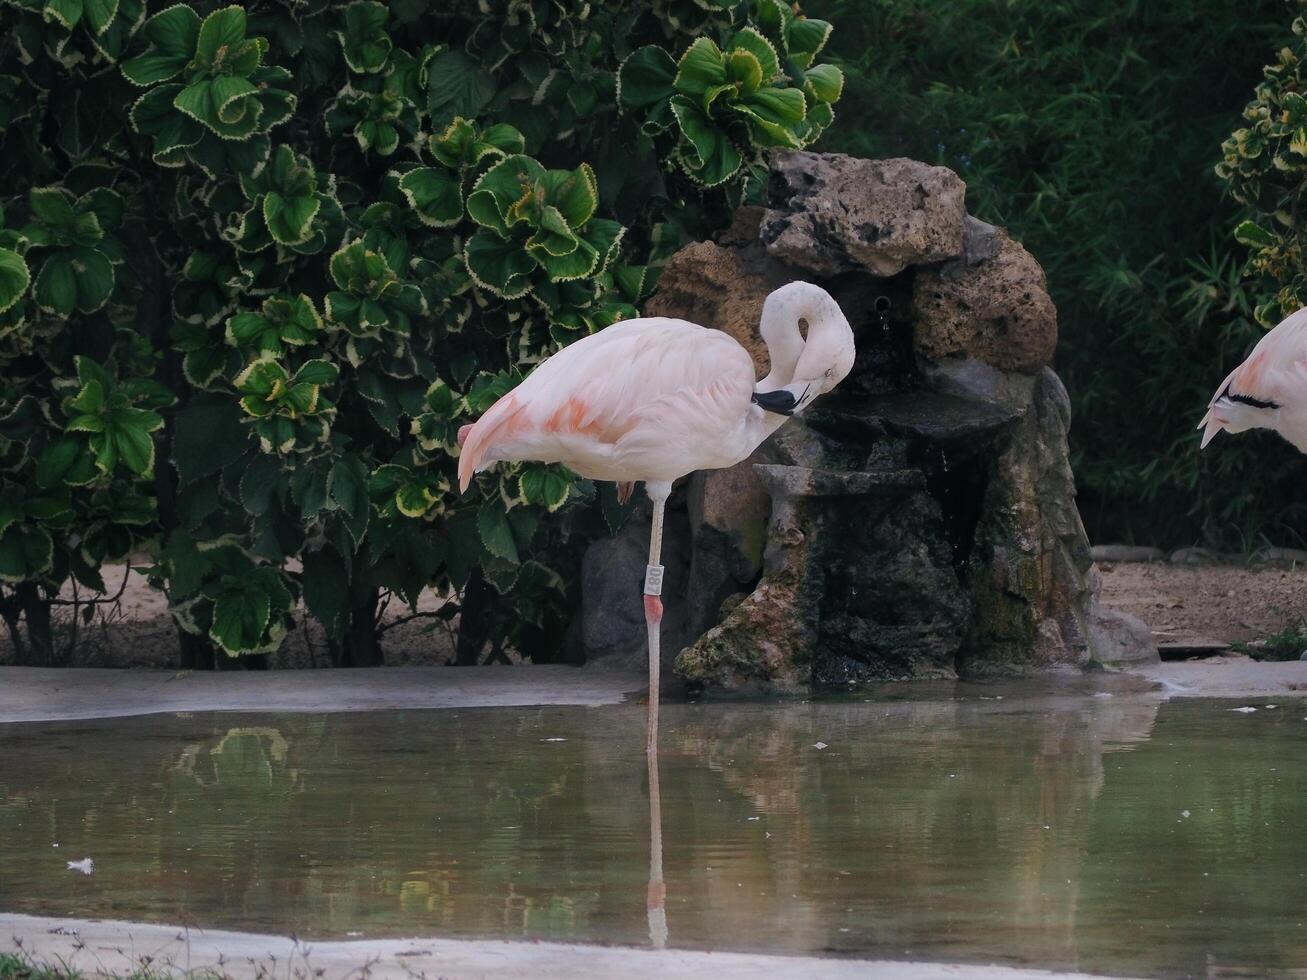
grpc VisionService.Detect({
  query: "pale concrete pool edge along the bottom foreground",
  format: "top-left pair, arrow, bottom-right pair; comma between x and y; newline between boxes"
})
0,913 -> 1144,980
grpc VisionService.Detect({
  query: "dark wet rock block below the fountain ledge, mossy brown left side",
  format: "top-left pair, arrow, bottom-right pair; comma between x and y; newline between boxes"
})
676,452 -> 968,693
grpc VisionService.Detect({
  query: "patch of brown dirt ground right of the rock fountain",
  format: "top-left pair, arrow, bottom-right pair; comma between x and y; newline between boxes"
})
1098,562 -> 1307,643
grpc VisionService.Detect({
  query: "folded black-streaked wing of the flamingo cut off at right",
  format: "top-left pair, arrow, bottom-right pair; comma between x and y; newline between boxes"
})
1199,310 -> 1307,448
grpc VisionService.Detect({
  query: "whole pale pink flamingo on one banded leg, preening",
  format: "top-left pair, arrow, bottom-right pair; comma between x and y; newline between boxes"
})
459,282 -> 853,751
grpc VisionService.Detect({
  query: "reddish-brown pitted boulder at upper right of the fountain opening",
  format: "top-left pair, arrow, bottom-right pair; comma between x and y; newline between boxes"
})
914,218 -> 1057,374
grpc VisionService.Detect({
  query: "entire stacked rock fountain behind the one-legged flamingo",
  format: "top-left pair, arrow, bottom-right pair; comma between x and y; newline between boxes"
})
582,153 -> 1157,691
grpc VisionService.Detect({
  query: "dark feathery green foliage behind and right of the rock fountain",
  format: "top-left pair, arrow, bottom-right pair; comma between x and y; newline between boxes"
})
806,0 -> 1307,547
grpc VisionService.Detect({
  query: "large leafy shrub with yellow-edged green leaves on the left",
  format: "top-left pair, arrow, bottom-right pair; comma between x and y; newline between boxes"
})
0,0 -> 843,665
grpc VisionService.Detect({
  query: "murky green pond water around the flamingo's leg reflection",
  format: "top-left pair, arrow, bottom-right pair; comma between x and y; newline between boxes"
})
0,695 -> 1307,976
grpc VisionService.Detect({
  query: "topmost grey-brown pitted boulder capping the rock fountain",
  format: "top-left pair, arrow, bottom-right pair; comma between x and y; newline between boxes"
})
759,153 -> 967,277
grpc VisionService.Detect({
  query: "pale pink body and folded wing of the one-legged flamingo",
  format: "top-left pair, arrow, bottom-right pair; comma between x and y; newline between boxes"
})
459,318 -> 754,490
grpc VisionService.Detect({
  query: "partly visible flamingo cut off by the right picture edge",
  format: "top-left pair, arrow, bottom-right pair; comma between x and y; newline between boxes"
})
1199,310 -> 1307,452
